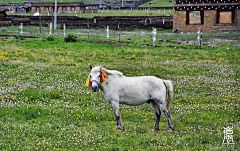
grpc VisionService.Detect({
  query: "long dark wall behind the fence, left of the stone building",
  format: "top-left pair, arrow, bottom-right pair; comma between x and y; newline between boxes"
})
8,15 -> 173,30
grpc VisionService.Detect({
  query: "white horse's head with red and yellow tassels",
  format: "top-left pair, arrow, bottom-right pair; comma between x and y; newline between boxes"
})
86,65 -> 106,92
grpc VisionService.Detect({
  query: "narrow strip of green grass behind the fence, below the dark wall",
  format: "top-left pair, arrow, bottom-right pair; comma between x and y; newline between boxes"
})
0,24 -> 240,42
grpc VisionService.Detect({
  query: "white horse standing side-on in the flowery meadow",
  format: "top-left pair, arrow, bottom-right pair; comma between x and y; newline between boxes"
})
89,65 -> 174,131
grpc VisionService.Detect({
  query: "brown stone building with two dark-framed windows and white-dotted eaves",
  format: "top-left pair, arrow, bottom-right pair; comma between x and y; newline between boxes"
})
173,0 -> 240,32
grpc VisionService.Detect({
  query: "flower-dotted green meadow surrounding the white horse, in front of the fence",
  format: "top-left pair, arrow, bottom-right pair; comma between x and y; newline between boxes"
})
0,31 -> 240,151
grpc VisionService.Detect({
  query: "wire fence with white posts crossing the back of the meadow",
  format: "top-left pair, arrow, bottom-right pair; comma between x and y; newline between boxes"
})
0,25 -> 240,44
